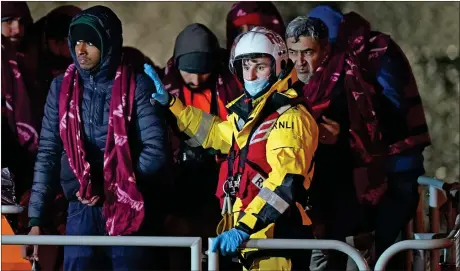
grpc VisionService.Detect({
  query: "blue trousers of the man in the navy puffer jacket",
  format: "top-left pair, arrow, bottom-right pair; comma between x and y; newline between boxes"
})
64,201 -> 151,271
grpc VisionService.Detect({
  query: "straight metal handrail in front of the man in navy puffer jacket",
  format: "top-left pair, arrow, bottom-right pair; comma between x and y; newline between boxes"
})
1,235 -> 202,271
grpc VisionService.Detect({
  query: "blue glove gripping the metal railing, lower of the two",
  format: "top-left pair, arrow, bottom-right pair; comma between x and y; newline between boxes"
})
212,228 -> 249,256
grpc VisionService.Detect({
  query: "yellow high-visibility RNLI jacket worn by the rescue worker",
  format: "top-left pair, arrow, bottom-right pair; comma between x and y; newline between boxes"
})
170,69 -> 318,243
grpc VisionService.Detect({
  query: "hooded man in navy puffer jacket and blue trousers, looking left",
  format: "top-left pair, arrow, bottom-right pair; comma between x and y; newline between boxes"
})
23,6 -> 168,270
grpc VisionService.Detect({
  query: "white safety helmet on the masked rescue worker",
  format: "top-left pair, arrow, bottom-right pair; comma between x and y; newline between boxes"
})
229,26 -> 289,80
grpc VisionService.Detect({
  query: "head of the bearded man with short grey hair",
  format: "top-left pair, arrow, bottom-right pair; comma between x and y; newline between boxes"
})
286,16 -> 329,84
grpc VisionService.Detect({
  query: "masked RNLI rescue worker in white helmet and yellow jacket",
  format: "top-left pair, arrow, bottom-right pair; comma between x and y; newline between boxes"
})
146,27 -> 318,270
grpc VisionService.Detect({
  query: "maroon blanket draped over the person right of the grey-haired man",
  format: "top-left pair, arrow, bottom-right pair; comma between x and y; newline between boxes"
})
304,12 -> 389,205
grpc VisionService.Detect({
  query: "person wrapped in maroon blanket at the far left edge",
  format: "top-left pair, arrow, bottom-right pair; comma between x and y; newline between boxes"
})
1,2 -> 40,240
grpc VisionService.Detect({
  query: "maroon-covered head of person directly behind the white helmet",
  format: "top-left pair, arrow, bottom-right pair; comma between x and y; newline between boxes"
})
227,1 -> 286,52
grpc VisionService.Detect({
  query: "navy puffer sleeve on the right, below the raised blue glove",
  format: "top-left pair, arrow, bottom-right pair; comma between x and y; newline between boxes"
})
135,75 -> 167,177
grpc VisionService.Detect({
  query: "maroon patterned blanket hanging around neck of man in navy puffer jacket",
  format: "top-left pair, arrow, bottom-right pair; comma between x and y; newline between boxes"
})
59,61 -> 144,236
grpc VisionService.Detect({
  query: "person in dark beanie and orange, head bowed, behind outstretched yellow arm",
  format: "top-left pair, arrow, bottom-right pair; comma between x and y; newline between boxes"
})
162,23 -> 242,269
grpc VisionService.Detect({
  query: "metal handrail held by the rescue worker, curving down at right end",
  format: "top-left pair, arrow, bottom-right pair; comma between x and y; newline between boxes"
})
208,238 -> 371,271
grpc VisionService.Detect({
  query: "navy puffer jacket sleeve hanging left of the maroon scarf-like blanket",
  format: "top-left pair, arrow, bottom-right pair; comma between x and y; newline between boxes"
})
29,76 -> 62,226
